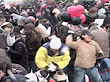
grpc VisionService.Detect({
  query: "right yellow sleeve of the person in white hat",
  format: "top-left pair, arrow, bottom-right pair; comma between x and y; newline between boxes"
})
55,50 -> 71,69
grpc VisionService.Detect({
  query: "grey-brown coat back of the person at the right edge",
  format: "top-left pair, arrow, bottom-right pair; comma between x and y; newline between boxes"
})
91,29 -> 109,58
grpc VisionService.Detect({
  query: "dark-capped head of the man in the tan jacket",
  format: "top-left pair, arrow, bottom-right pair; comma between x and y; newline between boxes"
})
81,29 -> 92,43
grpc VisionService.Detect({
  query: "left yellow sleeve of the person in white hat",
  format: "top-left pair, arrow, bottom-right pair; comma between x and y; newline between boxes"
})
35,47 -> 48,69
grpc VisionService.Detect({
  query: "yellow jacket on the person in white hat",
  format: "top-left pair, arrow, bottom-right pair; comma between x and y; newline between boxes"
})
35,44 -> 70,69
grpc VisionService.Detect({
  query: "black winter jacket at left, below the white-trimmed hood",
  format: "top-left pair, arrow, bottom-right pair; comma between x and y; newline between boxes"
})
8,39 -> 28,69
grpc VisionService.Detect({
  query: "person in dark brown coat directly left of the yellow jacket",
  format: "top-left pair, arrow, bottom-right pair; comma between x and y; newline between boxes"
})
21,23 -> 42,72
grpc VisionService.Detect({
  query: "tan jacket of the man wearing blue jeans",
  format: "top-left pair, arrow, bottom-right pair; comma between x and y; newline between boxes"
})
67,39 -> 103,68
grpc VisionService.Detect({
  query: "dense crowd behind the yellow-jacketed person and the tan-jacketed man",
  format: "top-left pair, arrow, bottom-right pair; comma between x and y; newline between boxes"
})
0,0 -> 110,82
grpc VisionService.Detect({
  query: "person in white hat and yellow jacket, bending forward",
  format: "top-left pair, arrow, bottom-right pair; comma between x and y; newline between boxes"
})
35,37 -> 70,71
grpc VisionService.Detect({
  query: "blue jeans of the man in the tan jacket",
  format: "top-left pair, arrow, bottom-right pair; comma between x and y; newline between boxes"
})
73,67 -> 103,82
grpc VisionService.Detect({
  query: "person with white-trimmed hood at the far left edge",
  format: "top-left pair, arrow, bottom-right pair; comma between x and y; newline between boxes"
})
0,22 -> 15,49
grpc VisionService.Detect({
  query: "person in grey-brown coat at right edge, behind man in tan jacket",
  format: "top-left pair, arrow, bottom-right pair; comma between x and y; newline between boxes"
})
89,24 -> 109,59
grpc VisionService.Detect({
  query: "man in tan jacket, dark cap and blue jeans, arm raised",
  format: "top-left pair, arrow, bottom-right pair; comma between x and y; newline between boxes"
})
66,29 -> 103,82
